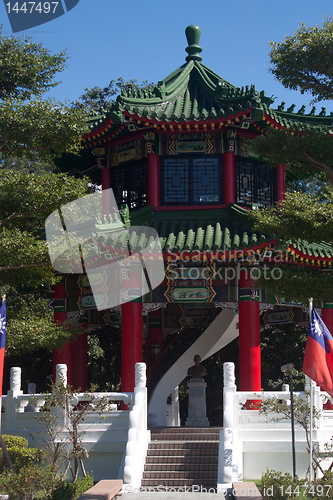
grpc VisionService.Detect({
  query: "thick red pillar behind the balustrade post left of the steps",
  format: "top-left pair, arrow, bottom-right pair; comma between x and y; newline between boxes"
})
121,299 -> 142,392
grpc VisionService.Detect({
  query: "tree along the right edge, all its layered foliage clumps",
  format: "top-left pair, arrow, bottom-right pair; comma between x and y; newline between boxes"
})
251,18 -> 333,302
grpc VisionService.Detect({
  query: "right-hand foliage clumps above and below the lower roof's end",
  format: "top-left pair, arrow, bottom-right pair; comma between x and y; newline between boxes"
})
250,189 -> 333,304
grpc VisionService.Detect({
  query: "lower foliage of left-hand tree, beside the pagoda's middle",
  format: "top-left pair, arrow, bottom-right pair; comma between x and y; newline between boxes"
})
0,166 -> 88,354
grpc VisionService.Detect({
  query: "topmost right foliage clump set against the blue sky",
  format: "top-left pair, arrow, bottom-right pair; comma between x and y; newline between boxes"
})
270,17 -> 333,101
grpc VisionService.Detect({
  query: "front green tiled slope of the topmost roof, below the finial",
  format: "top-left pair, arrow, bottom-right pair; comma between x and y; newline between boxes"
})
117,60 -> 261,123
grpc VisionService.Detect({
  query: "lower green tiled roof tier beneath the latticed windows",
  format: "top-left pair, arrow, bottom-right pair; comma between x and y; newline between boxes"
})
87,204 -> 333,267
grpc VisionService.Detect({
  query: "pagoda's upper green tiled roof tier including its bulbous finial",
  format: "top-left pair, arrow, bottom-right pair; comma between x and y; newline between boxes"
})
83,25 -> 333,147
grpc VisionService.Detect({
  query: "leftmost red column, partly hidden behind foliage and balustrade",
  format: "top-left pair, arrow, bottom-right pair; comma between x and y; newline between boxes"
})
53,282 -> 72,385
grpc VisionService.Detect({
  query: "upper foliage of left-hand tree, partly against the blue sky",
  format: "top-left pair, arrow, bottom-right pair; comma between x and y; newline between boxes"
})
0,28 -> 87,159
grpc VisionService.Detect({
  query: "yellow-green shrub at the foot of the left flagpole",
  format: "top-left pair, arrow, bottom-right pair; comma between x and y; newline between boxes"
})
0,434 -> 44,474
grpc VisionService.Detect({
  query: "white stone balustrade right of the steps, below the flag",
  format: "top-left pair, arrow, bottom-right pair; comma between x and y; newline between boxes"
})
218,363 -> 333,487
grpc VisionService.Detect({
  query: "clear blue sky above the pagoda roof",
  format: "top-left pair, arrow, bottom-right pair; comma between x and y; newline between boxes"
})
0,0 -> 333,112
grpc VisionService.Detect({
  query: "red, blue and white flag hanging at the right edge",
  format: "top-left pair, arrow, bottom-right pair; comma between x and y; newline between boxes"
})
303,309 -> 333,396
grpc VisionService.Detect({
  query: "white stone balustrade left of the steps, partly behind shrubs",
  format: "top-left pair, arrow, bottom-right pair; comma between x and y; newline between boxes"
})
1,363 -> 150,489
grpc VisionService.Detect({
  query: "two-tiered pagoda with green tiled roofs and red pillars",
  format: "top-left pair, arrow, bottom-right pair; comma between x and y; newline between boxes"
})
54,25 -> 333,426
